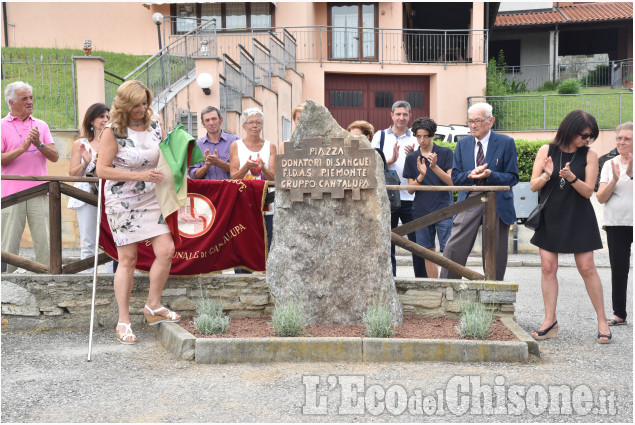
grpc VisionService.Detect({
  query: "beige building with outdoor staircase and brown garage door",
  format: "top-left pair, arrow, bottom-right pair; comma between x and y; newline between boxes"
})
2,1 -> 495,137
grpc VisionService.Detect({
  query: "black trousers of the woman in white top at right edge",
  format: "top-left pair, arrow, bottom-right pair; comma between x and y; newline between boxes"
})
606,226 -> 633,320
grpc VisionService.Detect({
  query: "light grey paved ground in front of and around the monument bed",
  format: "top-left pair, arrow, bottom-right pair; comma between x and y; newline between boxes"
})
1,255 -> 633,423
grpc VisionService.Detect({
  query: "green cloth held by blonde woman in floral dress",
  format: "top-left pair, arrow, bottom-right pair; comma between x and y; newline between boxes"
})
159,124 -> 205,192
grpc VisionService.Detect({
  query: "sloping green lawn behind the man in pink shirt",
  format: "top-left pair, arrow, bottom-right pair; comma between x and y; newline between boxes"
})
1,47 -> 148,129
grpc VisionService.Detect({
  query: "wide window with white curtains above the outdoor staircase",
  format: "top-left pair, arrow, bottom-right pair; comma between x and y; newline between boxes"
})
170,2 -> 274,34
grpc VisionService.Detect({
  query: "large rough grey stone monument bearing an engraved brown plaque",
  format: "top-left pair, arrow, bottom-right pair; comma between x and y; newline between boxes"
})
267,100 -> 403,325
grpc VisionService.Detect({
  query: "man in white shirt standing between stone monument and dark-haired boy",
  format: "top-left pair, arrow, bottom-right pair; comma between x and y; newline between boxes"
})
372,100 -> 428,277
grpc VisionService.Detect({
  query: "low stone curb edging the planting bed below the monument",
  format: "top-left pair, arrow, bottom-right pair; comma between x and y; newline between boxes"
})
157,318 -> 540,364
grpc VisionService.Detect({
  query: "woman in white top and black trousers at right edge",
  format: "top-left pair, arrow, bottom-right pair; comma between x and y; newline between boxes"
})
597,122 -> 633,326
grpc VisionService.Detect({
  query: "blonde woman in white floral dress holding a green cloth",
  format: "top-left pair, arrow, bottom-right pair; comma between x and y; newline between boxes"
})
97,80 -> 181,344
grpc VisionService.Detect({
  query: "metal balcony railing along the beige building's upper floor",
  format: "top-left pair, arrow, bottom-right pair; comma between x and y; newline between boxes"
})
168,21 -> 488,68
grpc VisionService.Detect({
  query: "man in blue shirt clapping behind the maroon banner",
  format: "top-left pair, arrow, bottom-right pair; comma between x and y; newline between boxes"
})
188,106 -> 239,180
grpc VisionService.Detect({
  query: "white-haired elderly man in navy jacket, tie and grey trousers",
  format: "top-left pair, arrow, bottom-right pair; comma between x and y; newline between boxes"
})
440,103 -> 518,280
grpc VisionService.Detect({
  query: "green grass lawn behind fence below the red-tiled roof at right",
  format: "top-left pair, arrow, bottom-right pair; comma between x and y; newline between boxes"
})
488,87 -> 633,130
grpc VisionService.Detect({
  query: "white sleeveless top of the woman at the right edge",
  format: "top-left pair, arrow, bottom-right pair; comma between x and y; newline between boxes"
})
600,155 -> 633,226
